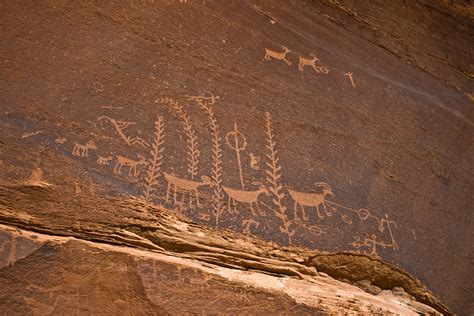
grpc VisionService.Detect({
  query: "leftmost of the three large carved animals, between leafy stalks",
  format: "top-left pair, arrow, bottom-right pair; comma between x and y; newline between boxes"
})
163,172 -> 212,207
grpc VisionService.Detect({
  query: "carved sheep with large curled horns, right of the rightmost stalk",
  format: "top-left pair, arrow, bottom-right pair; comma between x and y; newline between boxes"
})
287,182 -> 334,220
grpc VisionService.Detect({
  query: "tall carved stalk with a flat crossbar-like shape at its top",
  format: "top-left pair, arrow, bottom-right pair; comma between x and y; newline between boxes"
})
188,94 -> 224,226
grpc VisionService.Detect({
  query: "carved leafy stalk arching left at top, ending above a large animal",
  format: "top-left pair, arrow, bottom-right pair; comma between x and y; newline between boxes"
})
159,98 -> 200,180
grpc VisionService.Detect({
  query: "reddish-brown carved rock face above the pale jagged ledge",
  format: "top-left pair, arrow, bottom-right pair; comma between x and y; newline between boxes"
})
0,0 -> 474,314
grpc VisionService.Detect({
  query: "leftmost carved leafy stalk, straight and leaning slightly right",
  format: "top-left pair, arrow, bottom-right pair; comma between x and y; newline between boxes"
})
143,115 -> 165,201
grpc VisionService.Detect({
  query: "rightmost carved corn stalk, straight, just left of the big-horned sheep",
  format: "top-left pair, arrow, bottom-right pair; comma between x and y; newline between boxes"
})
265,112 -> 295,244
